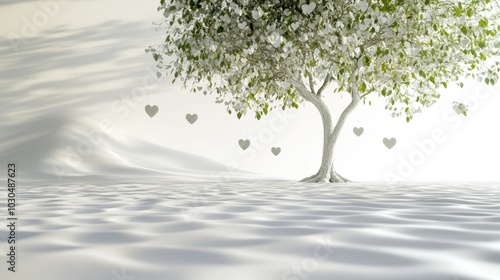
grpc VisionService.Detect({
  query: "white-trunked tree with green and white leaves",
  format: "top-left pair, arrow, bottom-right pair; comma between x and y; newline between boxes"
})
146,0 -> 500,182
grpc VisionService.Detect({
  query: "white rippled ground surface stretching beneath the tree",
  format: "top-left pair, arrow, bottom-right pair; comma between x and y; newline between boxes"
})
0,182 -> 500,280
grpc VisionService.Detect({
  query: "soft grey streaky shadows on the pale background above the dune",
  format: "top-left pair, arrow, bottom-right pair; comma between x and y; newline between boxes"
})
0,20 -> 164,173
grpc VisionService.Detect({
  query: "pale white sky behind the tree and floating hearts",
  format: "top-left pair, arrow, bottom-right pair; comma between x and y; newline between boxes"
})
0,0 -> 500,181
